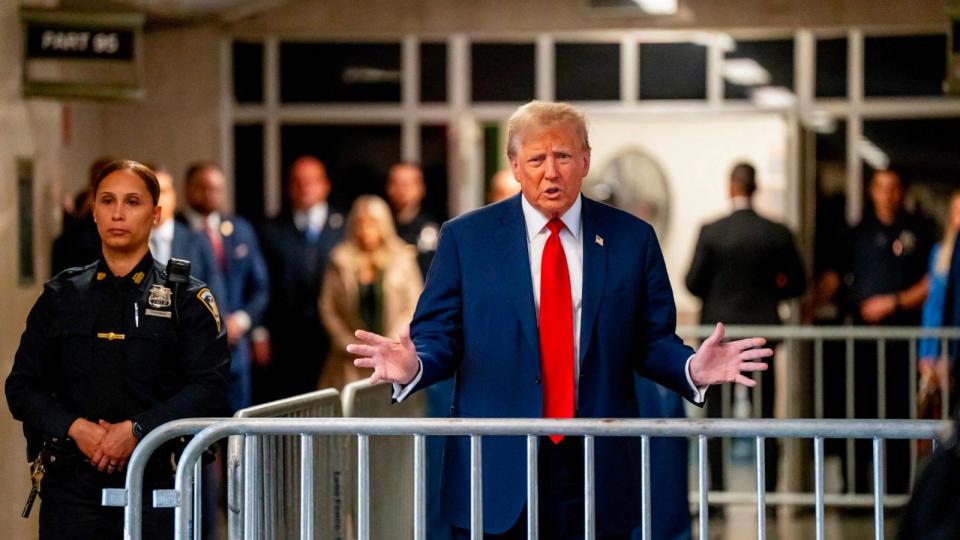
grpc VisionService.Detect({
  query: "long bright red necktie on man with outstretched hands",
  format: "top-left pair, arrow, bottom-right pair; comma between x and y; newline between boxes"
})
540,218 -> 575,443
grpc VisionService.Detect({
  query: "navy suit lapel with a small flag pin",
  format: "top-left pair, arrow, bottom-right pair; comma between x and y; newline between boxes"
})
580,197 -> 611,365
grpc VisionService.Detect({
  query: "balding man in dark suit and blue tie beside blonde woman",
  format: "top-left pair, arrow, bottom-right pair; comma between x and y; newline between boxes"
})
261,156 -> 344,399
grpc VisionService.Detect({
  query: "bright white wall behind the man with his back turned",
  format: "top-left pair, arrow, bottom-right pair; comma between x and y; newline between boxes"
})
590,113 -> 789,323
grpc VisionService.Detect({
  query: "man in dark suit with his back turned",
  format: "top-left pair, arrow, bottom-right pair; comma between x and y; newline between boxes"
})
686,163 -> 806,490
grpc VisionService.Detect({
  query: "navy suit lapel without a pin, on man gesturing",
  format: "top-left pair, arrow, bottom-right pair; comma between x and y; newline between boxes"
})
493,195 -> 540,356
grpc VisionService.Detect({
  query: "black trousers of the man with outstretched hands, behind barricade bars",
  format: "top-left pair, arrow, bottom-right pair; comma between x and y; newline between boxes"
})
453,437 -> 630,540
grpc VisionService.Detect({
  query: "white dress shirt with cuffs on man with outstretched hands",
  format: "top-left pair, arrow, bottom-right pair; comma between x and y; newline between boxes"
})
393,195 -> 707,403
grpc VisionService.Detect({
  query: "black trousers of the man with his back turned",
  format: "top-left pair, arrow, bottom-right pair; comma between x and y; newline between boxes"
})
704,343 -> 780,491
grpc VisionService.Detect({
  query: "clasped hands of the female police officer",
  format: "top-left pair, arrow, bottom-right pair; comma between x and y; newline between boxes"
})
67,418 -> 137,474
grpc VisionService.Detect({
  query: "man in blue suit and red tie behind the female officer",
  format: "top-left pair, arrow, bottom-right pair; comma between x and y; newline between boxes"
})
182,161 -> 270,411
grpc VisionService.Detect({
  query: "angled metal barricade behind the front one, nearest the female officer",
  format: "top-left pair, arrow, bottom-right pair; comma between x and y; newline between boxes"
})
227,388 -> 349,540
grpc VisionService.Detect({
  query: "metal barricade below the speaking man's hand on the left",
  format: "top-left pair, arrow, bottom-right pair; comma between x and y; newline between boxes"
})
342,379 -> 426,540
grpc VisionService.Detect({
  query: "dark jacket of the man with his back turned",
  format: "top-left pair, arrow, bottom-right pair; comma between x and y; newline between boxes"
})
686,209 -> 806,324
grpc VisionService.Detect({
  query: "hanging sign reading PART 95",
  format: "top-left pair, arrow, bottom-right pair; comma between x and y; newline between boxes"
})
20,9 -> 144,100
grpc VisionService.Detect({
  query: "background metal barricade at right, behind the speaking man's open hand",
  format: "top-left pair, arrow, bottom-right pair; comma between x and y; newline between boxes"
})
677,325 -> 960,506
